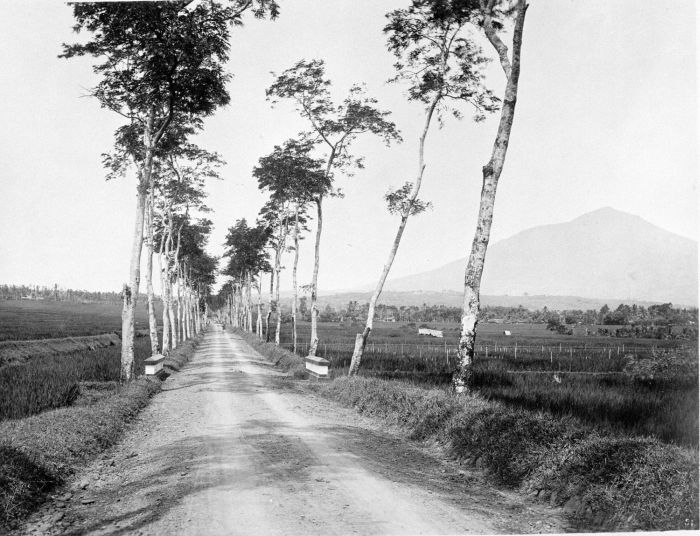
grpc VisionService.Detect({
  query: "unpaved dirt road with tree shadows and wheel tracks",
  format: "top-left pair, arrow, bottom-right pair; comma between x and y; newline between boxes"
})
21,326 -> 567,535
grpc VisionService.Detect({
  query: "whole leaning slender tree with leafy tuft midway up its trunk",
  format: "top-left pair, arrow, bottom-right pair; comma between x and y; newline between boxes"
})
349,0 -> 496,375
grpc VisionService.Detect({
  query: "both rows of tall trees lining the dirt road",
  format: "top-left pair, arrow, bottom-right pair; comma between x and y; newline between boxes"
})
62,0 -> 527,392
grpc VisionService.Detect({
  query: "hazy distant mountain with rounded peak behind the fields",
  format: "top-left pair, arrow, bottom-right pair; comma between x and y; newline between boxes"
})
370,208 -> 698,306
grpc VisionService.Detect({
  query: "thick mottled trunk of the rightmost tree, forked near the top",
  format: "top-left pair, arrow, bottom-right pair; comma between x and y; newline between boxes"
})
452,0 -> 527,393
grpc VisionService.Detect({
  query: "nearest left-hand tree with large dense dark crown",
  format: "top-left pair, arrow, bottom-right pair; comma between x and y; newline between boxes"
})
61,0 -> 277,381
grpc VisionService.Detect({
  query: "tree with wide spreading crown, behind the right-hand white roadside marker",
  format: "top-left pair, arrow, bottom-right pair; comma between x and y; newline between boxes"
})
267,60 -> 401,355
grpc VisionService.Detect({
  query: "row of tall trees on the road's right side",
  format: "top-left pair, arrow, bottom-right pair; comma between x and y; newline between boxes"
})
221,0 -> 527,392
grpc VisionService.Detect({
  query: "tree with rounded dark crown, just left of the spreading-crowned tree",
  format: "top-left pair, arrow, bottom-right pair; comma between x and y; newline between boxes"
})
253,136 -> 331,352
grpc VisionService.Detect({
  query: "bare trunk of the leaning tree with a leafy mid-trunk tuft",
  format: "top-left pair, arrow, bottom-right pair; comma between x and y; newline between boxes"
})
348,93 -> 442,376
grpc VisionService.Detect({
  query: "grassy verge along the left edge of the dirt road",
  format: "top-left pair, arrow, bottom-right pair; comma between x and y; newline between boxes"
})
0,338 -> 198,533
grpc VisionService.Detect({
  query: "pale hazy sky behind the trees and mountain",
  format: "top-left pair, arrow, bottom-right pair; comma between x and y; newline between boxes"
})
0,0 -> 698,290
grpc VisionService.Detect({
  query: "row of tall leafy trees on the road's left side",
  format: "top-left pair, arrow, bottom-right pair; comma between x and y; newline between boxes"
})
61,0 -> 278,381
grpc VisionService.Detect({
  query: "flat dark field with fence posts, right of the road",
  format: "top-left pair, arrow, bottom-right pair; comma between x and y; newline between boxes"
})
281,323 -> 698,445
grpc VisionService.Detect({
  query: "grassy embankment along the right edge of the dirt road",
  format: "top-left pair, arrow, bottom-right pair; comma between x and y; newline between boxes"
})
242,326 -> 699,531
